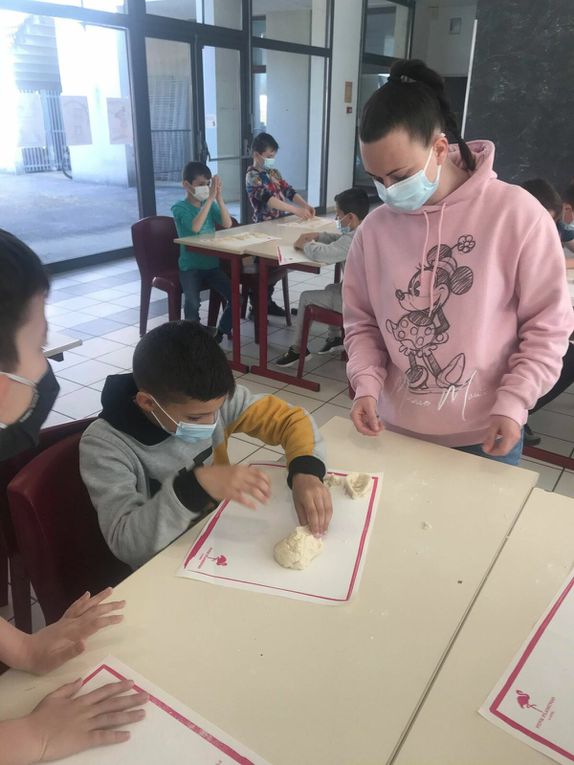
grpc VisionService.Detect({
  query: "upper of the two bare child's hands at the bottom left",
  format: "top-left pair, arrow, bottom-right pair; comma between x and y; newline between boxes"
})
16,587 -> 125,675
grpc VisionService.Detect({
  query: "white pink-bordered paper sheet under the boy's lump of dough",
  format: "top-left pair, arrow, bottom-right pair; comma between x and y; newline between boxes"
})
178,463 -> 382,605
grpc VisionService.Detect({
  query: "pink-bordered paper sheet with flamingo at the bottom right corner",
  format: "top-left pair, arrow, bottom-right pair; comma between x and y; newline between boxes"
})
479,574 -> 574,765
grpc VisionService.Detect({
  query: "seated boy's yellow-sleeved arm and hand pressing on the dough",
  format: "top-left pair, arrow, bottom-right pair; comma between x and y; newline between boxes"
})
223,386 -> 333,534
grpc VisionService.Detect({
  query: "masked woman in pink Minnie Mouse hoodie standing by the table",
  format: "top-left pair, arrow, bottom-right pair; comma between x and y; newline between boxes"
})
343,60 -> 574,464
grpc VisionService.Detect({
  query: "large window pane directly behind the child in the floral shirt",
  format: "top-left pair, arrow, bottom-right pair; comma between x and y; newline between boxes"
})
253,50 -> 325,205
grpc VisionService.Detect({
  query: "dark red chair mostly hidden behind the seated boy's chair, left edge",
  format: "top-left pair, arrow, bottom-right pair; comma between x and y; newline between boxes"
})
0,417 -> 93,632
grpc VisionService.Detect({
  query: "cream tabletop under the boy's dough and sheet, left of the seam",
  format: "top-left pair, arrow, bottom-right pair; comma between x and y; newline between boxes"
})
0,418 -> 536,765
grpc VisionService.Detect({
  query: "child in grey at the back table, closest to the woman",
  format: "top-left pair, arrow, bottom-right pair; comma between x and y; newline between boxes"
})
275,189 -> 369,367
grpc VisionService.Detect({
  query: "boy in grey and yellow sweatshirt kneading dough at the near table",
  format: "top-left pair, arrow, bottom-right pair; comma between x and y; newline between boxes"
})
80,321 -> 332,568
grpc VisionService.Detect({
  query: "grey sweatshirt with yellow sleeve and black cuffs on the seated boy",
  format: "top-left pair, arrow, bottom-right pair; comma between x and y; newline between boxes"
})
80,374 -> 325,568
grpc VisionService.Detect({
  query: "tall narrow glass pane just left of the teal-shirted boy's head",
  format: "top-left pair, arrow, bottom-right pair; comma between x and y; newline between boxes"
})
146,38 -> 197,215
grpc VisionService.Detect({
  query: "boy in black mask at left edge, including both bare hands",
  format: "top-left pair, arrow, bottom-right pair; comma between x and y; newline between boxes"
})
0,229 -> 147,765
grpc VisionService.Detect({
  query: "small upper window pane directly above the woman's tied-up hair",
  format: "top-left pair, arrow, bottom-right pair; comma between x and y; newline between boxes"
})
365,0 -> 409,58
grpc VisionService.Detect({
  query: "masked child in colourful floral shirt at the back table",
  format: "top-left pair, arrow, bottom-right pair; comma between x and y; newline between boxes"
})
245,133 -> 315,316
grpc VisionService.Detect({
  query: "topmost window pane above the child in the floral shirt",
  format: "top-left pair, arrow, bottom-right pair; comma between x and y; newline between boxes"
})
251,0 -> 327,47
